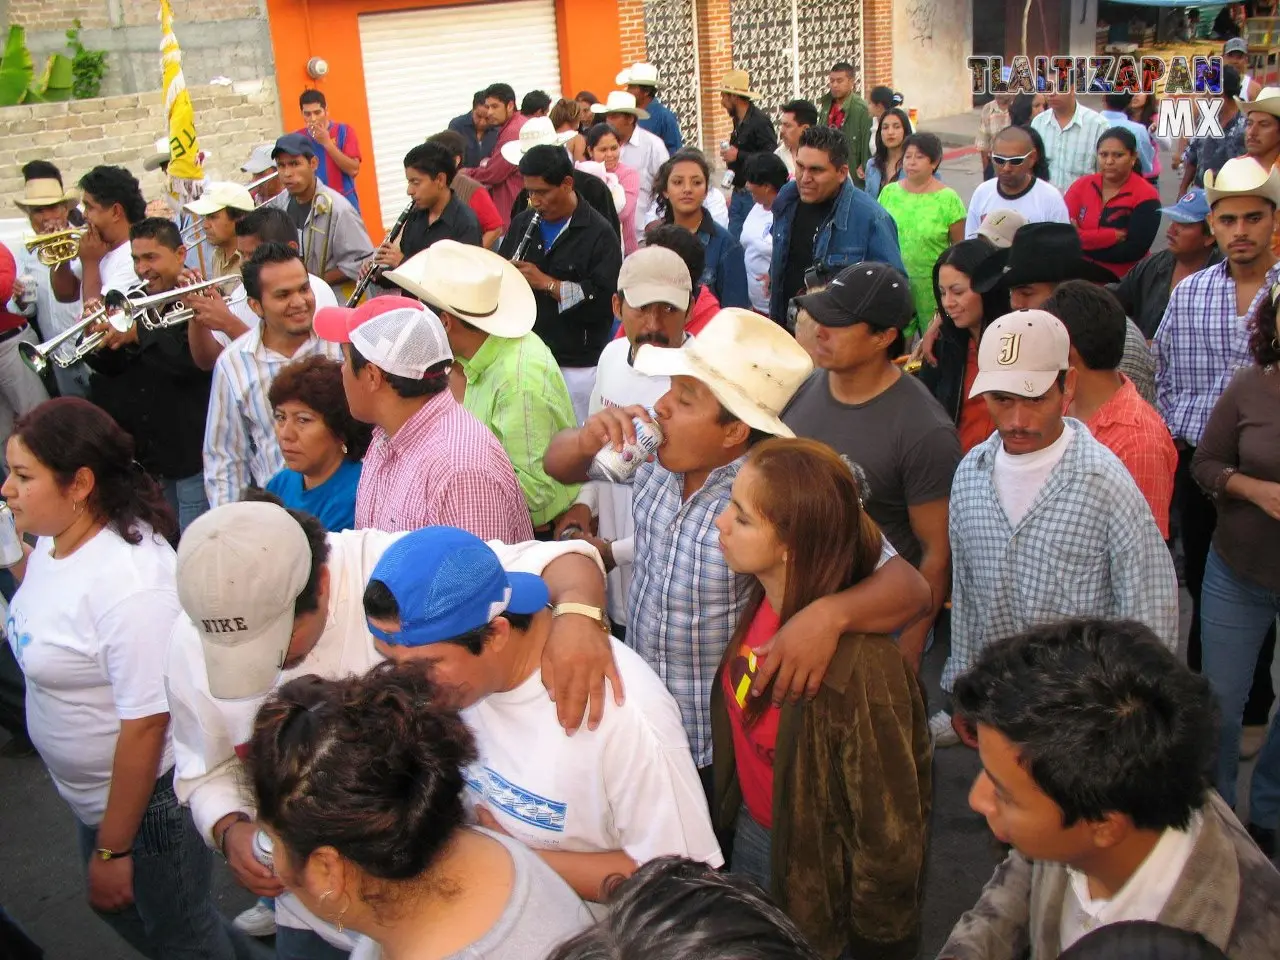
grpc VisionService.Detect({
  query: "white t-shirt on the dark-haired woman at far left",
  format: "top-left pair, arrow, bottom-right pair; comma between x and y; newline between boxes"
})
6,527 -> 182,827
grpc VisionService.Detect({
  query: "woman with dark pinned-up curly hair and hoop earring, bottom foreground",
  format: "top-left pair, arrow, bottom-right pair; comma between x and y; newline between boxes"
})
246,663 -> 591,960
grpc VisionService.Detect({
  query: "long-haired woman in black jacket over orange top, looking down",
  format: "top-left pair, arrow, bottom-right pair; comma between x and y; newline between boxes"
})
918,238 -> 1009,453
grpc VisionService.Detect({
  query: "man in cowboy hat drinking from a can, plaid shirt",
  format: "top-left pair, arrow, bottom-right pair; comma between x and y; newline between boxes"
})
547,307 -> 928,797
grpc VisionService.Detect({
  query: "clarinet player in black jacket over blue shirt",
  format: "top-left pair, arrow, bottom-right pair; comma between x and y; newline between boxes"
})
498,146 -> 622,422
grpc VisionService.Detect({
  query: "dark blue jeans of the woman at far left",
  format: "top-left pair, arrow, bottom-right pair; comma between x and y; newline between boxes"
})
76,772 -> 269,960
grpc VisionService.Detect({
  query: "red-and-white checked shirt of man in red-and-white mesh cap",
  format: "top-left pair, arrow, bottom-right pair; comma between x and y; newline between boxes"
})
356,390 -> 534,543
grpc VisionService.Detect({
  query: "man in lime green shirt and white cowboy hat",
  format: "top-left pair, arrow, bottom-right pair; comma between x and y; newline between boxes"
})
384,235 -> 577,535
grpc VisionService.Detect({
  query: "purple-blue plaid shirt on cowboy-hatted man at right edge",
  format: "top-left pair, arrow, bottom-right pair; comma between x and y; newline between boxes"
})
1152,260 -> 1280,447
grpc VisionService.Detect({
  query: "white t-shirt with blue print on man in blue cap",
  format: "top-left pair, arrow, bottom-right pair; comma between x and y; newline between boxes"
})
462,640 -> 724,885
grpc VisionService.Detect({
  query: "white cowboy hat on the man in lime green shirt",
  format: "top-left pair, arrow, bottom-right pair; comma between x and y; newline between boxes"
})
383,239 -> 538,339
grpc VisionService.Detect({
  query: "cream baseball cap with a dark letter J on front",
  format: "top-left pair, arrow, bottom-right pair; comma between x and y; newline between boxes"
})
969,310 -> 1071,397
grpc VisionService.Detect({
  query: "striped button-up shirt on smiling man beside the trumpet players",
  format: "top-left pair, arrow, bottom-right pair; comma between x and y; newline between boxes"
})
205,326 -> 342,507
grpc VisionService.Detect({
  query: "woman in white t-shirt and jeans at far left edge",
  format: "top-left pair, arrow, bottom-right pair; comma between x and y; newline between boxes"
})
3,397 -> 247,960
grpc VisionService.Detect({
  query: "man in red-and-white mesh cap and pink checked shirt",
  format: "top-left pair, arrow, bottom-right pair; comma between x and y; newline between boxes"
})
316,297 -> 534,543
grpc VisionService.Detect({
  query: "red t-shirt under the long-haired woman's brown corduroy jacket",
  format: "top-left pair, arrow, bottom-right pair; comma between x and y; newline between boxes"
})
722,600 -> 782,829
